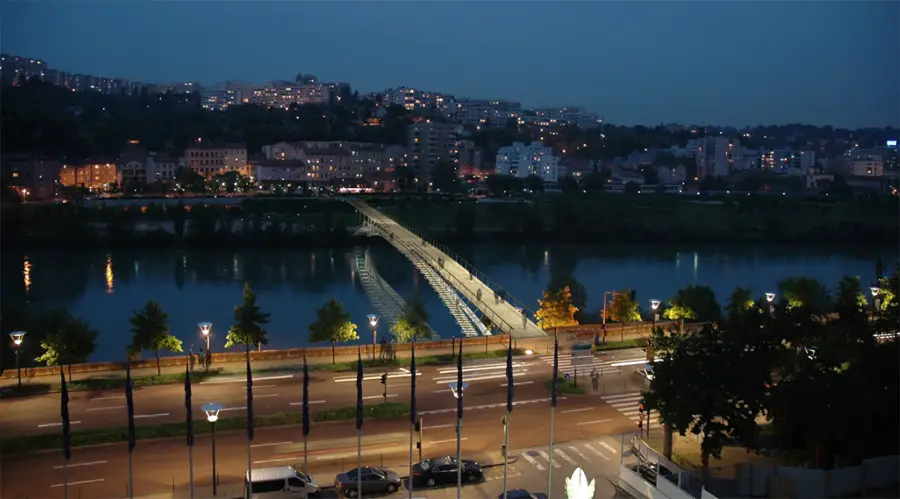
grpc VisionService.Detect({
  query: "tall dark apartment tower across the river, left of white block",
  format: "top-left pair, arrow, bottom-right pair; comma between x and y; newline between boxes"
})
406,122 -> 460,182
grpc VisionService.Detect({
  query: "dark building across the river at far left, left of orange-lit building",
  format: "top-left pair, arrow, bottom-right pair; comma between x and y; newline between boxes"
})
2,154 -> 62,201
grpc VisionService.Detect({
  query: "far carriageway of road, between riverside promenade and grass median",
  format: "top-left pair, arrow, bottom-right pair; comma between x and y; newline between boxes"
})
0,349 -> 644,435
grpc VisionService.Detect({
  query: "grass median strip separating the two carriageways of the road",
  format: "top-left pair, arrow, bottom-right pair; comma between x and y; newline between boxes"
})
2,402 -> 409,455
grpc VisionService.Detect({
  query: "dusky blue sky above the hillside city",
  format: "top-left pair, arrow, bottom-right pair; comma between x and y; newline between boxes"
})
2,0 -> 900,128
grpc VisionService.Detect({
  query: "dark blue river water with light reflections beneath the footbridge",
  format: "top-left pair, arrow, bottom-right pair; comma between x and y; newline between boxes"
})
2,244 -> 897,361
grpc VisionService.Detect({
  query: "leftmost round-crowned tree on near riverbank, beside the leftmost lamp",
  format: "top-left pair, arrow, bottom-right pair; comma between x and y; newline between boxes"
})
35,309 -> 97,381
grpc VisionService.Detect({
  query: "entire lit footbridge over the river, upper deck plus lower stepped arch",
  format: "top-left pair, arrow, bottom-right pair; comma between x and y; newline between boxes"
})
344,198 -> 546,338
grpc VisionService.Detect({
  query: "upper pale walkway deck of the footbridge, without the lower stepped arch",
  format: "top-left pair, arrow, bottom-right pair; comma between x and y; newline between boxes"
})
348,199 -> 546,338
